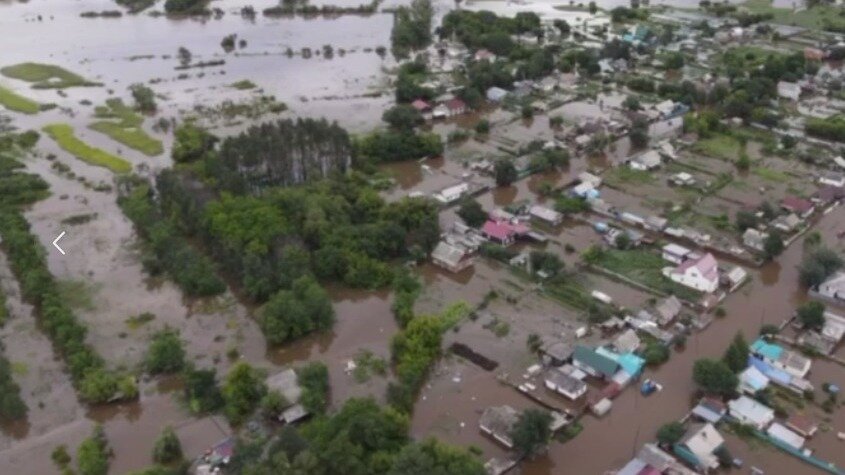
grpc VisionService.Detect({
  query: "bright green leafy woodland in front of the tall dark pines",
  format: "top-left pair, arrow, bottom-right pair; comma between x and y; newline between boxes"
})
157,168 -> 439,301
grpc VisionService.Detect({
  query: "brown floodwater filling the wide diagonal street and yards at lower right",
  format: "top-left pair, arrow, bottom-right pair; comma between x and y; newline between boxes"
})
524,207 -> 845,475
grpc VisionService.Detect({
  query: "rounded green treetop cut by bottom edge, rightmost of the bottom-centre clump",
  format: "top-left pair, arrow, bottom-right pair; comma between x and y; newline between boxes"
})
387,438 -> 486,475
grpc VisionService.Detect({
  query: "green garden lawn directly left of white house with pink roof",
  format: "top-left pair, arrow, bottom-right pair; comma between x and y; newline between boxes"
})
595,249 -> 701,302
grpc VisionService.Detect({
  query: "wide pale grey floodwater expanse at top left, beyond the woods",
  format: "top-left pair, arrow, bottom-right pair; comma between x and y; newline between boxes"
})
0,0 -> 393,131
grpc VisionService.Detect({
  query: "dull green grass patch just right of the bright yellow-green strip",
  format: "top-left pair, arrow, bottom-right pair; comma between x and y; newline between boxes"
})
88,99 -> 164,157
